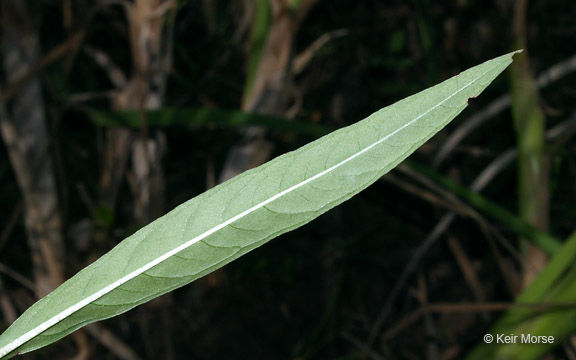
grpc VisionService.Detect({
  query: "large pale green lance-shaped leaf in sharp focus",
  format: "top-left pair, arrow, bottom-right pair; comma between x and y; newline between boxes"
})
0,50 -> 512,358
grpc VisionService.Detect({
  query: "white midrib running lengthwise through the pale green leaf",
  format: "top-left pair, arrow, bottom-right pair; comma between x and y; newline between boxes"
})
0,71 -> 488,358
